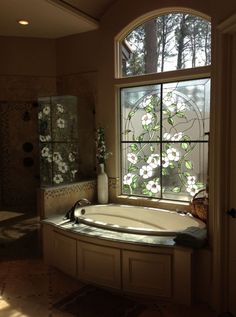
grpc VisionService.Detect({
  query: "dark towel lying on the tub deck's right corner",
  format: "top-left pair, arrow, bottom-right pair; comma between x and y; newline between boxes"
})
174,227 -> 207,249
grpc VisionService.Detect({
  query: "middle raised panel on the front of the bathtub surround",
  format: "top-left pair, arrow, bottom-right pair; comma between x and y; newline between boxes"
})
77,241 -> 121,289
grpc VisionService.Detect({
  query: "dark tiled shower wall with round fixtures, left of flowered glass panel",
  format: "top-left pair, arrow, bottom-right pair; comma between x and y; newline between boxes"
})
0,76 -> 56,212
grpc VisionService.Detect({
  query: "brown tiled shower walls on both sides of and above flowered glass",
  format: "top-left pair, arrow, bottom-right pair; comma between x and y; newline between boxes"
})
0,74 -> 96,212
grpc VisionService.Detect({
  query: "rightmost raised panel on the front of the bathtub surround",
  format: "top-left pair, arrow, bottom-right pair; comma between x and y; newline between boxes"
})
122,251 -> 172,298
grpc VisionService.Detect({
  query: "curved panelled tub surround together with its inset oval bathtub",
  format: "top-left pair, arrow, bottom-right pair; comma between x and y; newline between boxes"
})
42,204 -> 208,304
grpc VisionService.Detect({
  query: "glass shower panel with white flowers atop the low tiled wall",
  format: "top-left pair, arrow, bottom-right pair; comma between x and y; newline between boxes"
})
38,96 -> 79,187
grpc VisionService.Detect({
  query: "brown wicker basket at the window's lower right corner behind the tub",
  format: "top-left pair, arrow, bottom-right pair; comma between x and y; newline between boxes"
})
191,189 -> 208,222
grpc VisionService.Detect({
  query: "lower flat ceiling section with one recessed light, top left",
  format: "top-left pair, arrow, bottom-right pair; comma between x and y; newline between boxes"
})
0,0 -> 116,39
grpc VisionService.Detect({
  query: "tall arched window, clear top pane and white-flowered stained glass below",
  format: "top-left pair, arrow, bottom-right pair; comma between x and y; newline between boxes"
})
118,12 -> 211,201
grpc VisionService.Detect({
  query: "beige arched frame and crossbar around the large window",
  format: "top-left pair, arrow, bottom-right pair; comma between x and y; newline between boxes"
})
114,8 -> 212,209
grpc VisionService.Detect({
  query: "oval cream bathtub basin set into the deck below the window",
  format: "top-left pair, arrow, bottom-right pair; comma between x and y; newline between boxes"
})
74,204 -> 206,236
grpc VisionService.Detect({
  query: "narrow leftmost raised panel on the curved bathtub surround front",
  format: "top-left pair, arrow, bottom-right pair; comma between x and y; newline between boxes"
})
53,232 -> 76,276
